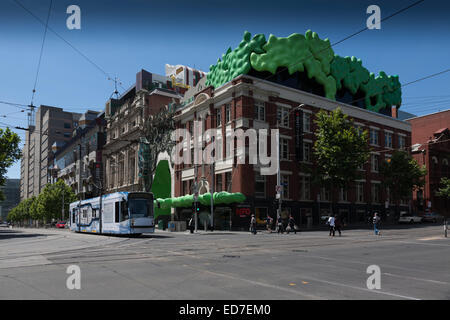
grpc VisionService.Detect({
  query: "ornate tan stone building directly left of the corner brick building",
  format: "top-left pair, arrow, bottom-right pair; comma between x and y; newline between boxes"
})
103,70 -> 187,193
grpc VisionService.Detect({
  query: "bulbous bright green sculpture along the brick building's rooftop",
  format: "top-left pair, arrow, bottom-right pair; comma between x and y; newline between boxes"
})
206,30 -> 401,112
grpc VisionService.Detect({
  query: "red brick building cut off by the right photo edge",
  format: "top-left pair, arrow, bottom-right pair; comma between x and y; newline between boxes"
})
407,110 -> 450,216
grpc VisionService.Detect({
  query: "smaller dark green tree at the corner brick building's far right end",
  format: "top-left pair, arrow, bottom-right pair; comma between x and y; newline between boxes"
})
379,150 -> 427,210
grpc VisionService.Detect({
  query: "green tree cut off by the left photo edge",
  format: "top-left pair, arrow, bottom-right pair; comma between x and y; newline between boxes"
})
0,128 -> 21,201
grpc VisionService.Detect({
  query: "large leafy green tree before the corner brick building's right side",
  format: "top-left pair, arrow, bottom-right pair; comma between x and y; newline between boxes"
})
313,108 -> 370,215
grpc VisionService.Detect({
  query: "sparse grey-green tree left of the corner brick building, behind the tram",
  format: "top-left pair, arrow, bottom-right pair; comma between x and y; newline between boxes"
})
139,107 -> 175,192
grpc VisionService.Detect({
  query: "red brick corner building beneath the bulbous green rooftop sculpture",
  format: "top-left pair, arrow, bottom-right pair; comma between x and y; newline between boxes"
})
174,75 -> 411,229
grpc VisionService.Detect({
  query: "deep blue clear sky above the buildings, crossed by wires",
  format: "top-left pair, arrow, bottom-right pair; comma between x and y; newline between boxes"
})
0,0 -> 450,178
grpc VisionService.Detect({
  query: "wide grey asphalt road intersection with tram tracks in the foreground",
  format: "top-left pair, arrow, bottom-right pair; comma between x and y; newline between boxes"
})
0,225 -> 450,300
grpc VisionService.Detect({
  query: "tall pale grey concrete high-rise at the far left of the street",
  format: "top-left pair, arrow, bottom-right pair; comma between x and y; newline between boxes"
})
20,105 -> 81,200
